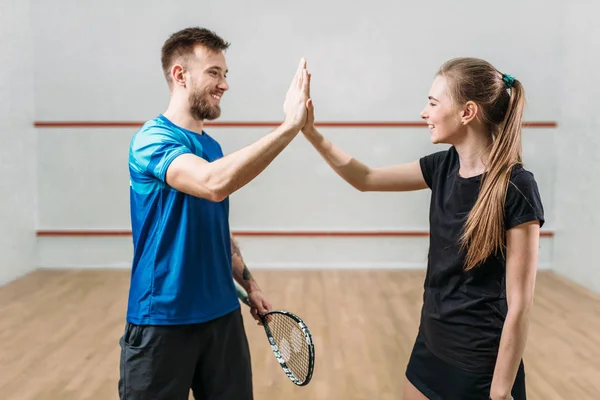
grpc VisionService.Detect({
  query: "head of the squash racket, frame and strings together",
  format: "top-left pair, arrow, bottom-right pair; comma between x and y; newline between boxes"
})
260,310 -> 315,386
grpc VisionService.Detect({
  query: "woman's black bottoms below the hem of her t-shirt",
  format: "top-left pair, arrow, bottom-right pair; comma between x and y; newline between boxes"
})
406,334 -> 526,400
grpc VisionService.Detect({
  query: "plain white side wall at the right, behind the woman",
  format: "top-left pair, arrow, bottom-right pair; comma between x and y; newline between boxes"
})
548,1 -> 600,293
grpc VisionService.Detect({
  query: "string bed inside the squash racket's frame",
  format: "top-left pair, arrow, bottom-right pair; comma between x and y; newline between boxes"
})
268,314 -> 310,379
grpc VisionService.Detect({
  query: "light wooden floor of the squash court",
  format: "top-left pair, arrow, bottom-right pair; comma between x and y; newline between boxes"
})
0,270 -> 600,400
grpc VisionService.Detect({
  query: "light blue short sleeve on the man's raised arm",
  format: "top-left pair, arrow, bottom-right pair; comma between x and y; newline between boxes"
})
130,127 -> 192,182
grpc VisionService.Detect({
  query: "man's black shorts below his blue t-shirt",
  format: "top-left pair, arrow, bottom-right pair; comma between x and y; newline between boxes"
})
118,308 -> 253,400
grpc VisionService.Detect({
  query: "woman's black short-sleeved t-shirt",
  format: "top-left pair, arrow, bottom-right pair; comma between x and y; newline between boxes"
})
419,147 -> 544,373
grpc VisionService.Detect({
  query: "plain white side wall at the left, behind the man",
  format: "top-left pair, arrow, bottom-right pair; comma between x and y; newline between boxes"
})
0,0 -> 37,285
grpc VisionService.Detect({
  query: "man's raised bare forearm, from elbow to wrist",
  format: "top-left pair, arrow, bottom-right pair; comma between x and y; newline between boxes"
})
207,124 -> 299,198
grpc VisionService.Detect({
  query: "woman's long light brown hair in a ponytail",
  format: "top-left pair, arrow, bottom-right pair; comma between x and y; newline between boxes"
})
438,58 -> 525,270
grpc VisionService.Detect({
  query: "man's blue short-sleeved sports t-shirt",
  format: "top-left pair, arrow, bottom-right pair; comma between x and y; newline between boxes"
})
127,115 -> 240,325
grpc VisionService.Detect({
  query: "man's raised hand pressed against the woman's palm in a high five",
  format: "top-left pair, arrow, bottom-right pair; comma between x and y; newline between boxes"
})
283,58 -> 310,130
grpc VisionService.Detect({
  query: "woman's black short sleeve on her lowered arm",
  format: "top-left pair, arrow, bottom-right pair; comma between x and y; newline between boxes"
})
505,170 -> 545,230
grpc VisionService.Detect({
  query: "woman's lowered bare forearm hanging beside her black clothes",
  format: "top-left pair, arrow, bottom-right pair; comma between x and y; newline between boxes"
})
491,310 -> 529,399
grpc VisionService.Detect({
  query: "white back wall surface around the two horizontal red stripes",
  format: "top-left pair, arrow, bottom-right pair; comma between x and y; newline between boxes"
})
33,0 -> 564,267
